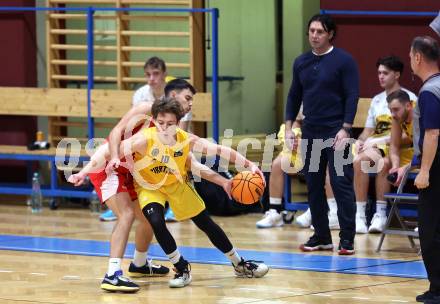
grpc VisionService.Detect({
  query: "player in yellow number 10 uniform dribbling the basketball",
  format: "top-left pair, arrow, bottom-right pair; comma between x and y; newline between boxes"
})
72,98 -> 269,287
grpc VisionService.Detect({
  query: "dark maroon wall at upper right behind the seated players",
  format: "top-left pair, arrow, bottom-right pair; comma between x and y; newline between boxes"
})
321,0 -> 440,97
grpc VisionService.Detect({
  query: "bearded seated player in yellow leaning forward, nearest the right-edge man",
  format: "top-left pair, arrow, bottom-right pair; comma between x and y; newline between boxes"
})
387,90 -> 415,186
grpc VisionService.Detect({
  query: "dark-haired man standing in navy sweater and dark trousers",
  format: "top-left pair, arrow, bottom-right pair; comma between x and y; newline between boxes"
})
286,15 -> 359,255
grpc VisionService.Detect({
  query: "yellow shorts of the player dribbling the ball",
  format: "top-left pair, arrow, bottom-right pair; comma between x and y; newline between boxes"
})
136,181 -> 205,221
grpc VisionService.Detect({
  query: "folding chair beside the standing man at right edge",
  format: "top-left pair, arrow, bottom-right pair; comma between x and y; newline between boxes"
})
376,165 -> 419,252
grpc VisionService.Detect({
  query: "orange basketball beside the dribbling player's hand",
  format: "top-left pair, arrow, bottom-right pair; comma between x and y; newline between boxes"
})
231,171 -> 264,205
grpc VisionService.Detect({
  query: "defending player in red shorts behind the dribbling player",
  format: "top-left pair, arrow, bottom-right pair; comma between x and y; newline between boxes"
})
74,79 -> 195,292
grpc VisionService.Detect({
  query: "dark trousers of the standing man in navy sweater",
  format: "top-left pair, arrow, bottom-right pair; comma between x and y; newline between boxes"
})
302,123 -> 356,241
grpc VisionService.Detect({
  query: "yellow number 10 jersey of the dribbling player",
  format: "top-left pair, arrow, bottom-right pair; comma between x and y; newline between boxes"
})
133,127 -> 190,187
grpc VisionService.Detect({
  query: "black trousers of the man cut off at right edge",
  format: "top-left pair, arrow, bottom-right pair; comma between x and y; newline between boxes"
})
419,152 -> 440,292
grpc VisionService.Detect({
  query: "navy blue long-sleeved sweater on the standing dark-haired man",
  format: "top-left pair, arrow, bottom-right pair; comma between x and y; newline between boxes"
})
286,48 -> 359,127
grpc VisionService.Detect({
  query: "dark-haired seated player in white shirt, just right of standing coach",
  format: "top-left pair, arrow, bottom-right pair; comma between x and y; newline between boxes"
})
353,56 -> 417,233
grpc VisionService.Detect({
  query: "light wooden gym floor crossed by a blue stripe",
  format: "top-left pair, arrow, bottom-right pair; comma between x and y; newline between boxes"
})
0,203 -> 428,304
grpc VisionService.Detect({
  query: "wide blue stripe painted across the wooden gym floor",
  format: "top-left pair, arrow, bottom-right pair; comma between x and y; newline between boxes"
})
0,235 -> 426,279
